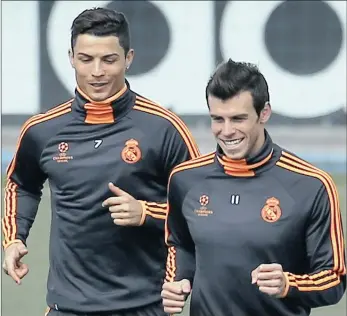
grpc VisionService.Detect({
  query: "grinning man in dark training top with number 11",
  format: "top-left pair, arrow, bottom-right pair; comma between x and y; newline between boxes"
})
162,60 -> 346,316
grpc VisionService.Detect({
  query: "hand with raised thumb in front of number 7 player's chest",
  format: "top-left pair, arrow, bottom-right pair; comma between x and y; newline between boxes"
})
102,183 -> 144,226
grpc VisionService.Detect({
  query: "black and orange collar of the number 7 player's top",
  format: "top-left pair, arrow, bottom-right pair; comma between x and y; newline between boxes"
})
74,81 -> 133,124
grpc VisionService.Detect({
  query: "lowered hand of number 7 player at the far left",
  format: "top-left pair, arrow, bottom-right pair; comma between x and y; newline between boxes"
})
2,242 -> 29,285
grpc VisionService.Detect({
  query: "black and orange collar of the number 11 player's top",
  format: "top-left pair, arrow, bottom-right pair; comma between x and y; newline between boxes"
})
216,130 -> 274,177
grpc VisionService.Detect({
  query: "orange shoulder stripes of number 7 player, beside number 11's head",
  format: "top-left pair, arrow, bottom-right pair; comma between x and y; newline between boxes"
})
134,97 -> 200,158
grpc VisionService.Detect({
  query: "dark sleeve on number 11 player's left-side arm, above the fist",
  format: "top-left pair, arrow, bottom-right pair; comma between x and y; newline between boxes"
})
165,171 -> 195,283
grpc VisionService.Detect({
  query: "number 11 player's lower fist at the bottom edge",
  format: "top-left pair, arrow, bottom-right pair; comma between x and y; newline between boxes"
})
161,279 -> 191,314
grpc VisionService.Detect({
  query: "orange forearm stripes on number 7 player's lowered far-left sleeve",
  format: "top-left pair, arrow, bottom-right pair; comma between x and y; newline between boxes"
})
2,180 -> 18,247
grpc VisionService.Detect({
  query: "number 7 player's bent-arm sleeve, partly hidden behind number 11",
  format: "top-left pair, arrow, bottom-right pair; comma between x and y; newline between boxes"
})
140,121 -> 200,231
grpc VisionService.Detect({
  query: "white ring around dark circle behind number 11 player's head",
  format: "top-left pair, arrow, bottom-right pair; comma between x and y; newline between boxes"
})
220,1 -> 346,118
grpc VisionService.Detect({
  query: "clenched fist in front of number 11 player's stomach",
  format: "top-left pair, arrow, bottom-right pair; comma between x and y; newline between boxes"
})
252,263 -> 287,297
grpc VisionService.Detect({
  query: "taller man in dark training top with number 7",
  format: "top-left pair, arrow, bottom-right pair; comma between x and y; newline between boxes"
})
3,8 -> 199,316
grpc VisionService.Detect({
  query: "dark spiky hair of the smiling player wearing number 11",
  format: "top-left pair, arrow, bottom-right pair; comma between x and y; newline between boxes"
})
206,59 -> 270,116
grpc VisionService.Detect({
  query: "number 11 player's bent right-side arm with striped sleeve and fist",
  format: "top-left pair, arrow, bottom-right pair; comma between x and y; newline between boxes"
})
252,180 -> 346,308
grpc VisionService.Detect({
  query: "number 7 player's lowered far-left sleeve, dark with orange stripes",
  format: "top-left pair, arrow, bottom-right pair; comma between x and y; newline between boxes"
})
2,129 -> 47,249
